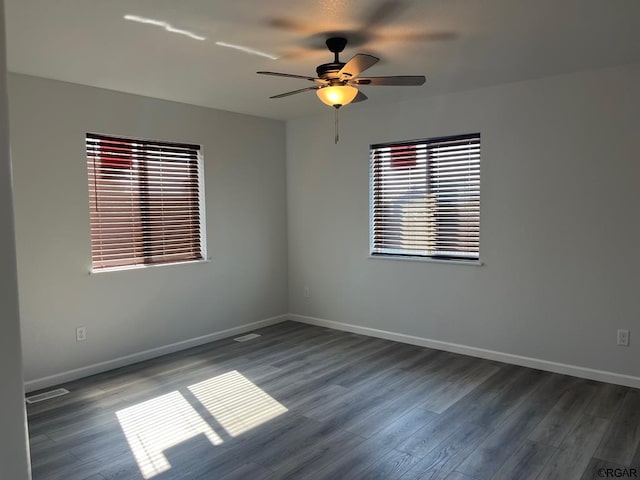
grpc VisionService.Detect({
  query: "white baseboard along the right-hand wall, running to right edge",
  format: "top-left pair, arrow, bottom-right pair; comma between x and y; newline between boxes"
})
288,314 -> 640,388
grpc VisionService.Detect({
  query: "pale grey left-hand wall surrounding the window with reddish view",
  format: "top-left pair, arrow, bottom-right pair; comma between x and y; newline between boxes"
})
9,74 -> 287,388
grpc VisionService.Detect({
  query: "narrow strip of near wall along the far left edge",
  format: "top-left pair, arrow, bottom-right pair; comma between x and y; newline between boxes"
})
0,0 -> 31,480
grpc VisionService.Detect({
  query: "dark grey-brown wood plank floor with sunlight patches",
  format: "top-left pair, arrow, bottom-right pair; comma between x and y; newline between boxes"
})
28,322 -> 640,480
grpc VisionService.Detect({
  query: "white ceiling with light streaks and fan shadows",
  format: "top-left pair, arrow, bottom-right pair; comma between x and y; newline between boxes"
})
5,0 -> 640,119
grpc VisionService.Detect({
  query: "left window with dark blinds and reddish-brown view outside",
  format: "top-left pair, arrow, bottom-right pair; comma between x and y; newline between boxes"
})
86,133 -> 205,270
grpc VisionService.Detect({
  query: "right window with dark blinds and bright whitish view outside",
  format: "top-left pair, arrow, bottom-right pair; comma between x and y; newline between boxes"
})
370,133 -> 480,260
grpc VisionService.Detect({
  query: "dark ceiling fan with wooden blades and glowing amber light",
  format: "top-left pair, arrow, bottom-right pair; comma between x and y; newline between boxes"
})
257,37 -> 425,109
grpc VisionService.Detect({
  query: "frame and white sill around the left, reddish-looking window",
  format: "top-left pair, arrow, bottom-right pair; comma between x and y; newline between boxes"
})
84,132 -> 210,274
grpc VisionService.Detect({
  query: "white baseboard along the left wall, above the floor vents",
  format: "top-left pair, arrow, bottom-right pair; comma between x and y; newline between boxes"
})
24,315 -> 289,393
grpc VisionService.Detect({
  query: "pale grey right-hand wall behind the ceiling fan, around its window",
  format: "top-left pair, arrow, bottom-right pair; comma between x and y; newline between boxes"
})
287,66 -> 640,377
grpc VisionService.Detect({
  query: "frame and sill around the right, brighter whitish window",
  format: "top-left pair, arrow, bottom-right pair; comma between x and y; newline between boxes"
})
368,132 -> 484,266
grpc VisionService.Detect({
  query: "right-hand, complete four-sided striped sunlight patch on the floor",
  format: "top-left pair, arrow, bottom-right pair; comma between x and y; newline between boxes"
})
189,370 -> 287,437
